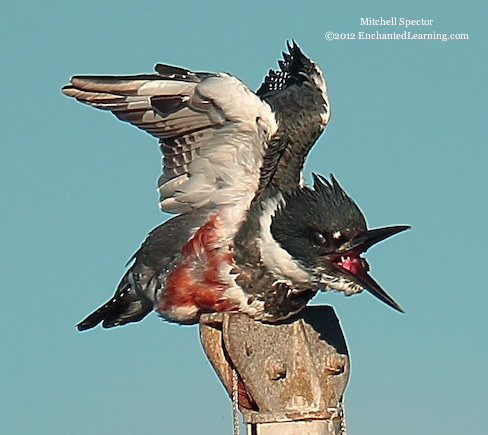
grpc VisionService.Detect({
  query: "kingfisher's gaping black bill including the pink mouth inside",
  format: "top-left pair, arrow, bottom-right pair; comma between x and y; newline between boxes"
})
326,225 -> 410,313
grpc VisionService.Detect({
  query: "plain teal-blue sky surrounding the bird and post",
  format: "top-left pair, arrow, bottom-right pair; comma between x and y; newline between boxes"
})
0,0 -> 488,435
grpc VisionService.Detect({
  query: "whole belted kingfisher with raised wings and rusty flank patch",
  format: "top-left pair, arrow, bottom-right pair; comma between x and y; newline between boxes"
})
62,43 -> 409,330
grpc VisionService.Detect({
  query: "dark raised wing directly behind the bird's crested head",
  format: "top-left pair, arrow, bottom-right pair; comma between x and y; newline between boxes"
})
257,42 -> 330,193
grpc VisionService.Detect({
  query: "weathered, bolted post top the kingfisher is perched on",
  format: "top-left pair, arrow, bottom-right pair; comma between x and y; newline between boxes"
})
200,306 -> 349,435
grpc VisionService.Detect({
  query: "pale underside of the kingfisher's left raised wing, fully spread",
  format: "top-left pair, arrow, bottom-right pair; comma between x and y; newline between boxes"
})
62,65 -> 277,214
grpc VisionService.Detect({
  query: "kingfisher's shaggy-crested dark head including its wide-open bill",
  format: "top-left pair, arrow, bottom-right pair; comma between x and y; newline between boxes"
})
271,174 -> 410,312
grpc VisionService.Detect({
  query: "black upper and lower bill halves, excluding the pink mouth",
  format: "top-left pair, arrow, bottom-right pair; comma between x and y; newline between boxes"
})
339,225 -> 410,313
